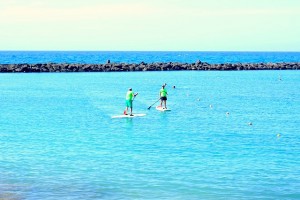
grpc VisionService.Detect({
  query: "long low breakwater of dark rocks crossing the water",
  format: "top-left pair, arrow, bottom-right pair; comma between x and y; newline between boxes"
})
0,61 -> 300,73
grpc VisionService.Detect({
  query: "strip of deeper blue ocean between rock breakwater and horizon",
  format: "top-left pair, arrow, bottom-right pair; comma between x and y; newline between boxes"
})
0,51 -> 300,64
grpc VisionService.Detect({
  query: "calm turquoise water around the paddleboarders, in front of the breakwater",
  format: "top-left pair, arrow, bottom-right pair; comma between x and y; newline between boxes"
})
0,71 -> 300,200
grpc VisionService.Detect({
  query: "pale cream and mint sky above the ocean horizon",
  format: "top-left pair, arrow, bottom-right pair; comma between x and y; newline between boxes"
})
0,0 -> 300,51
